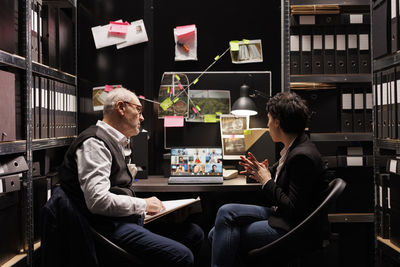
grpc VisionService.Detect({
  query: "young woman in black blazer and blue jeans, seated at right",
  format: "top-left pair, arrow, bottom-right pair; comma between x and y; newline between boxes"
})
209,92 -> 327,266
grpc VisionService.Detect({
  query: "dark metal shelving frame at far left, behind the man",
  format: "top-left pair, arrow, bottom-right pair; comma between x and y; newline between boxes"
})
0,0 -> 77,266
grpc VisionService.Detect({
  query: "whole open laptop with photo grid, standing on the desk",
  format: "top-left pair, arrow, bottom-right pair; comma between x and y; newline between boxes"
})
168,147 -> 224,184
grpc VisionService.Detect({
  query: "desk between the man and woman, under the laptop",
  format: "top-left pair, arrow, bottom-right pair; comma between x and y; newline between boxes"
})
133,175 -> 261,193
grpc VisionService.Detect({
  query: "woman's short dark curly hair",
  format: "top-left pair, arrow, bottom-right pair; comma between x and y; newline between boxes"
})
267,92 -> 310,134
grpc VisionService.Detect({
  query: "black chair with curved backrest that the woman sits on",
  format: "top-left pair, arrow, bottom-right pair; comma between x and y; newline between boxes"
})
246,178 -> 346,266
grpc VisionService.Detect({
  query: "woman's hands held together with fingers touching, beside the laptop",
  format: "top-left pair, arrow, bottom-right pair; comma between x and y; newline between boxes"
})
239,152 -> 271,184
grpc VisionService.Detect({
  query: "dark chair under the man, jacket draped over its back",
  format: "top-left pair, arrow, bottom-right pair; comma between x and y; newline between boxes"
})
41,187 -> 144,267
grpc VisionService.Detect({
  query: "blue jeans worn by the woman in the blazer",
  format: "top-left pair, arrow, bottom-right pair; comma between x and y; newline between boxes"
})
208,204 -> 285,267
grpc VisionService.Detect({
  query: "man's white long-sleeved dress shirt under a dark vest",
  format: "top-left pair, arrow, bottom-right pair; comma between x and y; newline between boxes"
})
76,121 -> 146,217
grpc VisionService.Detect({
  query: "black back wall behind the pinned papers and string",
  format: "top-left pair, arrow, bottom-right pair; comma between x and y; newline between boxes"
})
78,0 -> 281,174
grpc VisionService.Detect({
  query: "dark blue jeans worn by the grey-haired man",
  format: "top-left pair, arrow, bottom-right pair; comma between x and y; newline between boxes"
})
101,222 -> 204,267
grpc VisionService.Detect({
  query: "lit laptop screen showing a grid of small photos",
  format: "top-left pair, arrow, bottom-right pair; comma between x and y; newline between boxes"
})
171,147 -> 222,177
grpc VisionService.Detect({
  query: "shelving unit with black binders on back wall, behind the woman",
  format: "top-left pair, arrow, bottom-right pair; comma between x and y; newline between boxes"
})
288,0 -> 374,266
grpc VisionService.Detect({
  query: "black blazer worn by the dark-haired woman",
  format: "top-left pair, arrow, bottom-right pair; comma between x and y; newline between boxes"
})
263,134 -> 328,234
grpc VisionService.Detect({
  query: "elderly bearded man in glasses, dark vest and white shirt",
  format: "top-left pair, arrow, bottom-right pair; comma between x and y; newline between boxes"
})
60,88 -> 204,266
